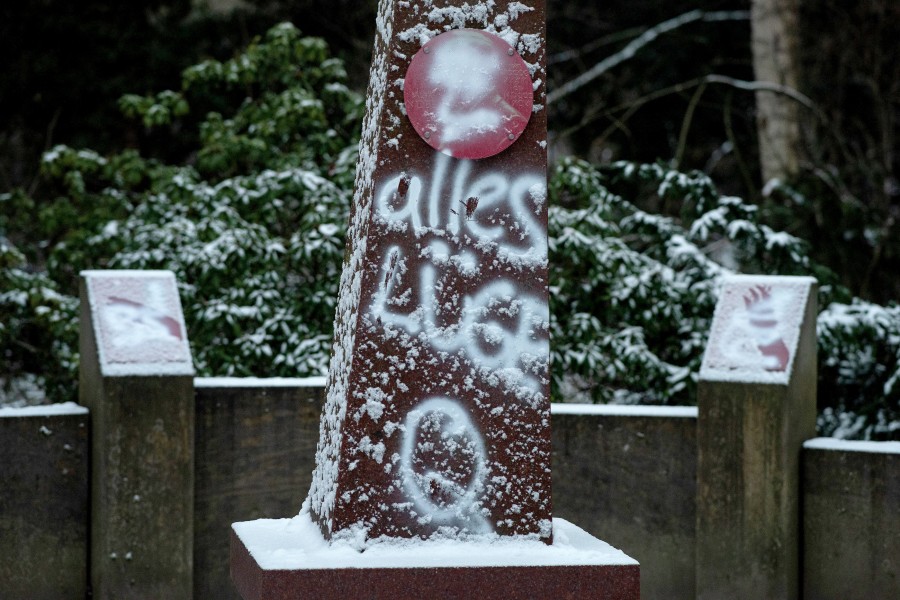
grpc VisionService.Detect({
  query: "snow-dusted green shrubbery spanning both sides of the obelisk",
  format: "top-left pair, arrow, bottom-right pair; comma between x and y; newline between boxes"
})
0,25 -> 900,438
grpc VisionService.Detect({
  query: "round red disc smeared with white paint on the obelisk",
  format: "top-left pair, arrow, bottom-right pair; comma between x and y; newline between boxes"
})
403,29 -> 534,158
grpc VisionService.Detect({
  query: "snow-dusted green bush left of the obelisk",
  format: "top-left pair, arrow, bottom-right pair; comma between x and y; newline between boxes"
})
0,24 -> 363,399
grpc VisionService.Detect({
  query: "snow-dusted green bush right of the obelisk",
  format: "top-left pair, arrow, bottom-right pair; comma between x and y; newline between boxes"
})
550,160 -> 900,438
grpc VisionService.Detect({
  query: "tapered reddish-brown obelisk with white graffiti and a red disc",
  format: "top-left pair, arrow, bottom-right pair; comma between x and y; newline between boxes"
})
304,0 -> 552,546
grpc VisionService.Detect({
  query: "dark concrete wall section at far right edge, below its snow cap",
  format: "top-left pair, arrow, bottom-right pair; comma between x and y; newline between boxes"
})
803,448 -> 900,600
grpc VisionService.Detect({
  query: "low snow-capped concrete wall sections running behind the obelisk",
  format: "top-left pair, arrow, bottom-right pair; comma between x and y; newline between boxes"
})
0,379 -> 900,600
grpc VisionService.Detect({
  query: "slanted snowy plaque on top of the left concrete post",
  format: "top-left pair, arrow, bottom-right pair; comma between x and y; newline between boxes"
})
82,271 -> 194,376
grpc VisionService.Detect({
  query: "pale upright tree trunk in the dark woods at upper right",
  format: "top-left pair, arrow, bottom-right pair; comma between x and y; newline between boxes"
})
751,0 -> 801,183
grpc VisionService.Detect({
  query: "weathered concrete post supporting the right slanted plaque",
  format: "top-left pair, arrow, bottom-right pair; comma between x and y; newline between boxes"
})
697,284 -> 817,600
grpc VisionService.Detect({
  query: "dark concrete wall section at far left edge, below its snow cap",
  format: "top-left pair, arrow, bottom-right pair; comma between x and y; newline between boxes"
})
0,414 -> 90,600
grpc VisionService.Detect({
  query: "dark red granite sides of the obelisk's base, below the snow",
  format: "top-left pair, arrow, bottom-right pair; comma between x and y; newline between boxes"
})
231,530 -> 640,600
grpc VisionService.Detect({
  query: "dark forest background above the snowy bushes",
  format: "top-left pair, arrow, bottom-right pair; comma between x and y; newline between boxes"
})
0,0 -> 900,303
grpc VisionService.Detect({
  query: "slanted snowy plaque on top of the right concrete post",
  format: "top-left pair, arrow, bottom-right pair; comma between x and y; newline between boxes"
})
700,275 -> 816,384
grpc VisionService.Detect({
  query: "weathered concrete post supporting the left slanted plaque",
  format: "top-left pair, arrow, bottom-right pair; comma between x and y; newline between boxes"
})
79,279 -> 194,600
